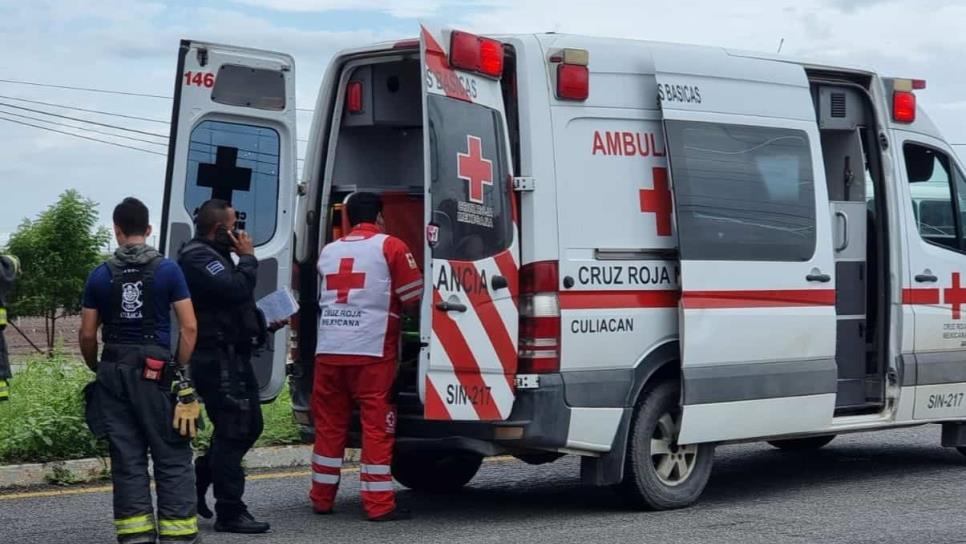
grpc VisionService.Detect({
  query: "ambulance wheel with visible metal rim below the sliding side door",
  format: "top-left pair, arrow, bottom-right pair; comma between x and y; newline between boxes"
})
617,381 -> 714,510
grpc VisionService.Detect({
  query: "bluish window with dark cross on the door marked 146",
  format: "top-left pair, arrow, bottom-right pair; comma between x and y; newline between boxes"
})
185,121 -> 279,246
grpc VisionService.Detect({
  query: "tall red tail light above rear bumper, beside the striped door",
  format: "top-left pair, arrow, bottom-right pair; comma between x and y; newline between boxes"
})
517,261 -> 560,374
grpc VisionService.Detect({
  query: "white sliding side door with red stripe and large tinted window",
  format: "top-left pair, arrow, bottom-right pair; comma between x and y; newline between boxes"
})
654,47 -> 837,444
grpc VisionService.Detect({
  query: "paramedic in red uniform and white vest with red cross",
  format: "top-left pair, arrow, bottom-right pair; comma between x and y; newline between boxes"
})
310,193 -> 423,521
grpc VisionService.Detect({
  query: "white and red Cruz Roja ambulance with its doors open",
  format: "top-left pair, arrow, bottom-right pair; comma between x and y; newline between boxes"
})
162,26 -> 966,509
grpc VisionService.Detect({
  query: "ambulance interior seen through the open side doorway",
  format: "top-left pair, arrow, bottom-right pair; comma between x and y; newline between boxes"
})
810,73 -> 889,415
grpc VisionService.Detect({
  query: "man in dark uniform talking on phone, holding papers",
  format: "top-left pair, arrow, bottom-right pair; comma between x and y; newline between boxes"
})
179,199 -> 270,534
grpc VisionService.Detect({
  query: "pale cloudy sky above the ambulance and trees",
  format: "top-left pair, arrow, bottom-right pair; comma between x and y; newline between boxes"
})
0,0 -> 966,243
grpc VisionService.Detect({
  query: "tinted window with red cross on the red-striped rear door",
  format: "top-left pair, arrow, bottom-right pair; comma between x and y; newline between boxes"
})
427,95 -> 513,261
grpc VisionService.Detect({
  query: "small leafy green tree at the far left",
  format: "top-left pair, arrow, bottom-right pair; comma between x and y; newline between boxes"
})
6,190 -> 110,356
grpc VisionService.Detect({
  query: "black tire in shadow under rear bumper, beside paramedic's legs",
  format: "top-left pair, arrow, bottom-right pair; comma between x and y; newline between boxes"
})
392,451 -> 483,493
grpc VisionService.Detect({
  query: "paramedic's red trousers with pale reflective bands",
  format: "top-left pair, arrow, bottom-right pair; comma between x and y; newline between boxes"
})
309,359 -> 396,518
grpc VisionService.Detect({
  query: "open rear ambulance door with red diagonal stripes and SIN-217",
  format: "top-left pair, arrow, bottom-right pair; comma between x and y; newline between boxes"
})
419,26 -> 519,421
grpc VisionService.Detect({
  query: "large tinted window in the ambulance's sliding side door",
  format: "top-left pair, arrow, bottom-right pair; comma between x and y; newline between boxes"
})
667,121 -> 815,261
